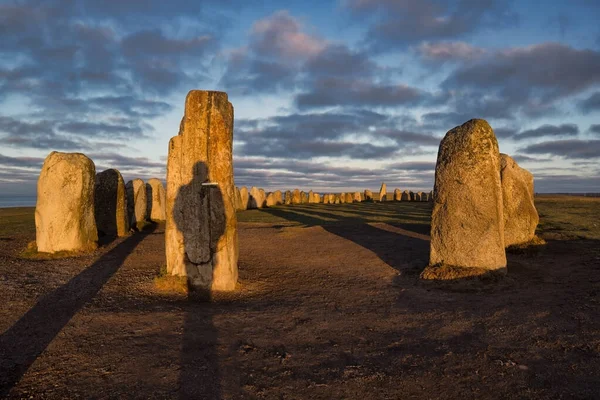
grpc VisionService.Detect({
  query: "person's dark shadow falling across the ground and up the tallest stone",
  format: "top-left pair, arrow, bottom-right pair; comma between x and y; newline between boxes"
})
172,162 -> 227,399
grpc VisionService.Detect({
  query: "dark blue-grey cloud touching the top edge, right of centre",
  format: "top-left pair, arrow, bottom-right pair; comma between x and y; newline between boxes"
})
345,0 -> 517,50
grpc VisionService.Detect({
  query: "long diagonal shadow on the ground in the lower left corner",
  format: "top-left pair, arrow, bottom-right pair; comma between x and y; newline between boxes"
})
0,226 -> 156,397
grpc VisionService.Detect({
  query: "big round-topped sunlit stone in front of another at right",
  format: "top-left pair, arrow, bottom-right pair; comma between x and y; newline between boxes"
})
429,119 -> 506,271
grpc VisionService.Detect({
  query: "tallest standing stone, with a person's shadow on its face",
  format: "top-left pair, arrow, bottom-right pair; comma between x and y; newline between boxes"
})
165,90 -> 241,291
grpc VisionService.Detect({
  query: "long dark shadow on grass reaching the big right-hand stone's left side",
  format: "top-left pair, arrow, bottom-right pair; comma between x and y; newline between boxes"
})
262,205 -> 429,274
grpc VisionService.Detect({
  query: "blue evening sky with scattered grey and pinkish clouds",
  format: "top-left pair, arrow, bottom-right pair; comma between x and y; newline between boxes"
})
0,0 -> 600,196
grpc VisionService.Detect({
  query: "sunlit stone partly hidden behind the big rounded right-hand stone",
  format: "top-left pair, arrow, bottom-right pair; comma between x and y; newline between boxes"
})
500,154 -> 540,247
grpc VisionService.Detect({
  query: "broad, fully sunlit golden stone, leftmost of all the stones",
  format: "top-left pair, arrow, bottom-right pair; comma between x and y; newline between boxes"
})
35,151 -> 98,253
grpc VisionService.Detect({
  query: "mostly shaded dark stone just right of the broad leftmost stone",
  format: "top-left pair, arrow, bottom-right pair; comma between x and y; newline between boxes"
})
94,169 -> 129,236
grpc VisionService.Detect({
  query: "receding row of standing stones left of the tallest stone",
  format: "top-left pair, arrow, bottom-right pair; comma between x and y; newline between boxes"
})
35,151 -> 165,253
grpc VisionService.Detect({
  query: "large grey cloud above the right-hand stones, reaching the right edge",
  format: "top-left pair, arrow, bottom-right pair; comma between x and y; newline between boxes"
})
442,43 -> 600,115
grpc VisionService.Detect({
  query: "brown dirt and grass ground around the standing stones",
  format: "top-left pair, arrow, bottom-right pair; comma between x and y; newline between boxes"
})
0,198 -> 600,400
